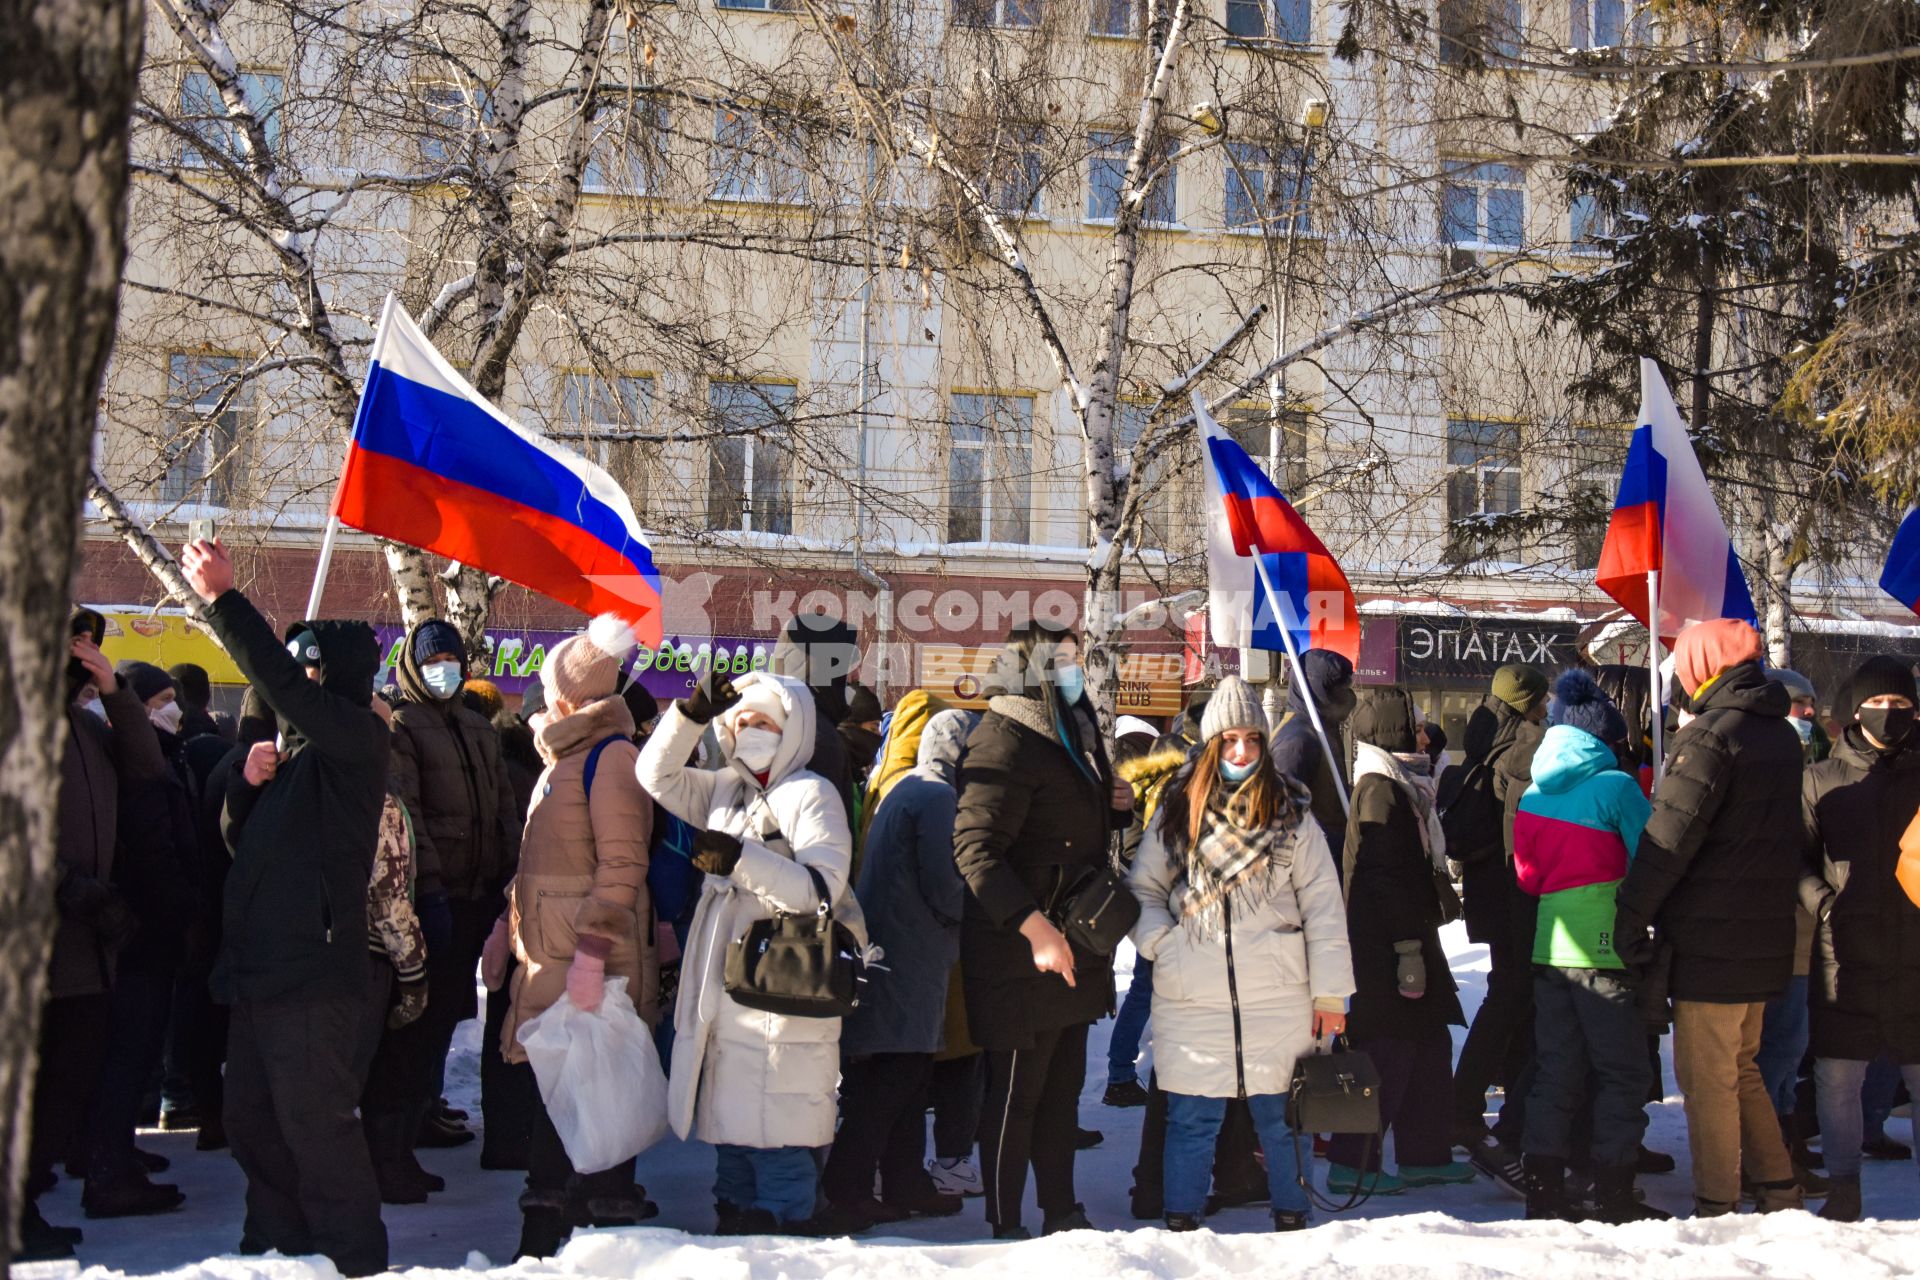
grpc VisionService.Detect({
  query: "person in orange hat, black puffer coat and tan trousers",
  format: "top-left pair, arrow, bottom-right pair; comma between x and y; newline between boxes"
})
1615,618 -> 1805,1217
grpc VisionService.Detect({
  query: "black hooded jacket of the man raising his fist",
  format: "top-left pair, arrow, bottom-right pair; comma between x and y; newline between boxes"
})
207,591 -> 392,1002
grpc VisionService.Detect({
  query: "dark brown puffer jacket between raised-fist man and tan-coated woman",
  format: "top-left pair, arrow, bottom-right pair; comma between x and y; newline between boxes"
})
394,628 -> 520,900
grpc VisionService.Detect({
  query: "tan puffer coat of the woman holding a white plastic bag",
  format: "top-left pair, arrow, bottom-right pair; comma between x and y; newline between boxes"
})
501,697 -> 660,1063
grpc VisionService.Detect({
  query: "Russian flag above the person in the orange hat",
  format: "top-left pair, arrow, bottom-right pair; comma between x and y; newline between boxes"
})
1597,359 -> 1755,643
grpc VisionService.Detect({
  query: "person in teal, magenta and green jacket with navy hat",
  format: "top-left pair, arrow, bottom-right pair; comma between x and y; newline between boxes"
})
1513,670 -> 1667,1222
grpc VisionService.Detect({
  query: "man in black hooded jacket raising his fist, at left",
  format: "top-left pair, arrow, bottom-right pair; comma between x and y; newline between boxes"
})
180,541 -> 388,1276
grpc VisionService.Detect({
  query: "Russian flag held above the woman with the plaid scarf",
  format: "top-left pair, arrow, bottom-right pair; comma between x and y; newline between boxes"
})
1194,395 -> 1359,662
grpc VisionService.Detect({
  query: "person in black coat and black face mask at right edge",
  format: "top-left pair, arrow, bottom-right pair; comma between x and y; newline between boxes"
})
1801,658 -> 1920,1222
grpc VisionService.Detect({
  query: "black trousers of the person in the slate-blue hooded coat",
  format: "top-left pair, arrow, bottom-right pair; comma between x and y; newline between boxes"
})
822,1054 -> 933,1205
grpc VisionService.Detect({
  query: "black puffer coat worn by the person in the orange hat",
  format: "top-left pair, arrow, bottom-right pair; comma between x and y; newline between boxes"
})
1615,662 -> 1805,1004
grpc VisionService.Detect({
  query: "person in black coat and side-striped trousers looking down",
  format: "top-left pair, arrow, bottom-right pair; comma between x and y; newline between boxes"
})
954,624 -> 1133,1240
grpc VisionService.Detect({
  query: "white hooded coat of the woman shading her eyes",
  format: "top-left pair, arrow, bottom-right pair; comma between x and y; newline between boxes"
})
637,672 -> 864,1148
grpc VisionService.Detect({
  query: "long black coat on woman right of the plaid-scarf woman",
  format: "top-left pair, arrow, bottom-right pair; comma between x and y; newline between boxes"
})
1340,773 -> 1467,1038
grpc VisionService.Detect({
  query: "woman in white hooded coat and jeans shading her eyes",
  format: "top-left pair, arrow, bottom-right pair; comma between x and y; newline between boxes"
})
637,672 -> 864,1234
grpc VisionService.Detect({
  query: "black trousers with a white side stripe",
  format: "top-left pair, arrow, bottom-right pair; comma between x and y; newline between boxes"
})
979,1023 -> 1087,1226
